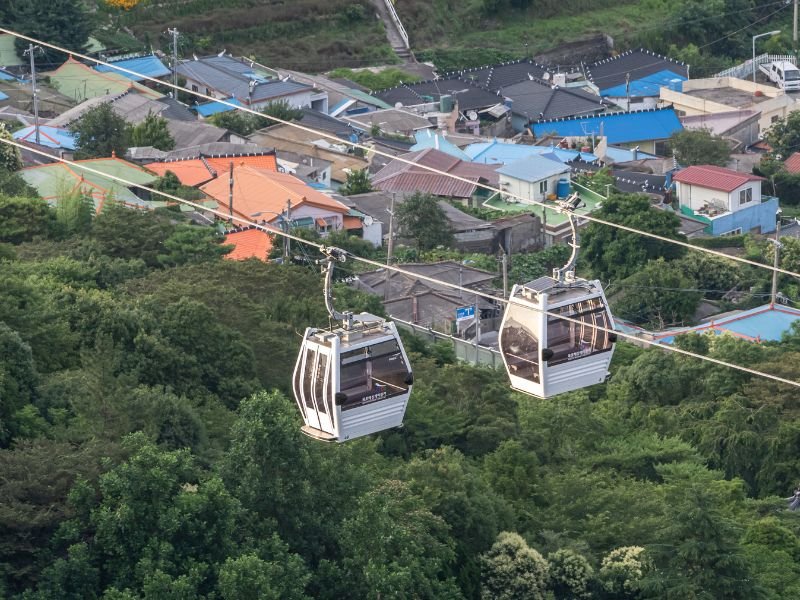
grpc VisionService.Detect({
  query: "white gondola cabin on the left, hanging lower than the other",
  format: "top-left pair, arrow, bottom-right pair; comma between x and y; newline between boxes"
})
293,313 -> 413,442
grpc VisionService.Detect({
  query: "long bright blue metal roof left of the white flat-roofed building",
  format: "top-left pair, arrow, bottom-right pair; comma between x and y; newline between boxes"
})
533,108 -> 683,144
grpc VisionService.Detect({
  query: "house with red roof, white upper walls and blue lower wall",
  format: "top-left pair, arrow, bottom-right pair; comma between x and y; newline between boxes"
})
673,165 -> 778,236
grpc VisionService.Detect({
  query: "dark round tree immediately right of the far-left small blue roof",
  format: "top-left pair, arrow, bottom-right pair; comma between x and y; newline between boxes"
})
69,102 -> 130,158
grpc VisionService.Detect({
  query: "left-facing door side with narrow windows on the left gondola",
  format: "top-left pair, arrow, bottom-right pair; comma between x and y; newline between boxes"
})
298,342 -> 337,437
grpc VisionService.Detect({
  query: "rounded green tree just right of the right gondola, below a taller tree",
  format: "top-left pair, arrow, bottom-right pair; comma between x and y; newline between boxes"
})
612,259 -> 703,330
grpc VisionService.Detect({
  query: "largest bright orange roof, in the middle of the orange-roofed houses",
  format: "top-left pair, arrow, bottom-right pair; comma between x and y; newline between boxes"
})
200,165 -> 349,222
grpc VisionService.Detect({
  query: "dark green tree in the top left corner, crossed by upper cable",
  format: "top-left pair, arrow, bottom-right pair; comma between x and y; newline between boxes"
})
7,0 -> 93,67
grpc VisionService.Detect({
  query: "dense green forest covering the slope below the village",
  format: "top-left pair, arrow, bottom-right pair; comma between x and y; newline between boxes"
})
0,189 -> 800,600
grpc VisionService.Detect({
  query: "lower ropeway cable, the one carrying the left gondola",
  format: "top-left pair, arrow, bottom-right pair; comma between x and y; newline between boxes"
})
0,138 -> 800,388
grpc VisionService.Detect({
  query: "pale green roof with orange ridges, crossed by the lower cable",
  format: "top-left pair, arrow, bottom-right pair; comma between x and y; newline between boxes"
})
19,158 -> 158,208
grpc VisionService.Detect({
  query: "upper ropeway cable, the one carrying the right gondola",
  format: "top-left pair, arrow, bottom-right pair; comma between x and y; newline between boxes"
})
0,27 -> 800,279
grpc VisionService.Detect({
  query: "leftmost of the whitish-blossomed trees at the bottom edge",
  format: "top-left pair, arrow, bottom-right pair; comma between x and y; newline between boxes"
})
481,531 -> 549,600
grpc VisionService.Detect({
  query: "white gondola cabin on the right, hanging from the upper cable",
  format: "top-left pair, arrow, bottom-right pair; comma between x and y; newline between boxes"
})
500,277 -> 616,398
